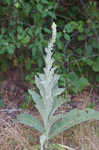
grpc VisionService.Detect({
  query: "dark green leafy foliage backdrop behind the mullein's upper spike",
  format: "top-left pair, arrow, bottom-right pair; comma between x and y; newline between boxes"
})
0,0 -> 99,93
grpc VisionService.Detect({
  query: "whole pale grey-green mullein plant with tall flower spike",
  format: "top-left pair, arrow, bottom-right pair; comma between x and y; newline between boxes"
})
17,23 -> 99,150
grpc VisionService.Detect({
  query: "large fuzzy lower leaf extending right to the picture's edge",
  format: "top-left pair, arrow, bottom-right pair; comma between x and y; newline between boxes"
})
50,108 -> 99,138
